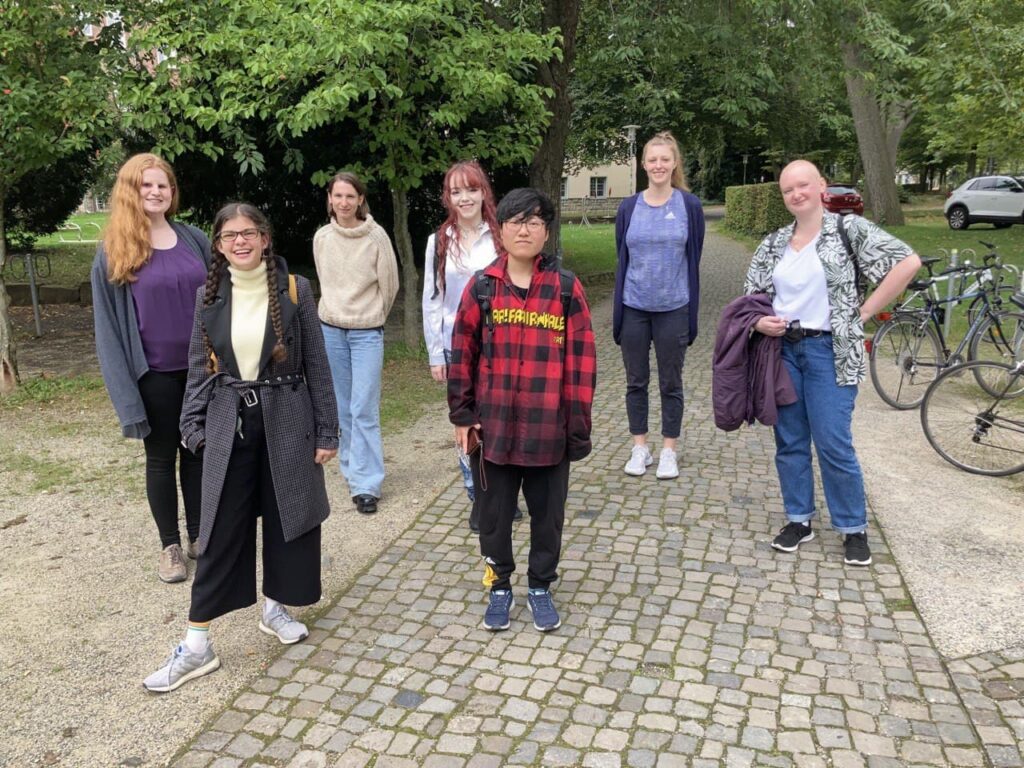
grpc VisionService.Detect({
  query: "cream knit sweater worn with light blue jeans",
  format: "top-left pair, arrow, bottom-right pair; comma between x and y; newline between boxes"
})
313,216 -> 398,329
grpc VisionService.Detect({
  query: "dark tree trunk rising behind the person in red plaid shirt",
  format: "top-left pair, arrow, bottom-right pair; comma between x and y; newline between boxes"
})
529,0 -> 581,259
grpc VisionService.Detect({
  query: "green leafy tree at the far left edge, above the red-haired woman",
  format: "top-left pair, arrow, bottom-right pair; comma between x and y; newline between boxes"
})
0,0 -> 120,391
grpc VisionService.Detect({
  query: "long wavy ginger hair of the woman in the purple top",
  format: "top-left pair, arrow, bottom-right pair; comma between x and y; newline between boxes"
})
103,153 -> 178,284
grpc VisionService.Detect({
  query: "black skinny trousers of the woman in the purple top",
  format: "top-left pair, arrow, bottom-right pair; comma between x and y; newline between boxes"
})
138,371 -> 203,547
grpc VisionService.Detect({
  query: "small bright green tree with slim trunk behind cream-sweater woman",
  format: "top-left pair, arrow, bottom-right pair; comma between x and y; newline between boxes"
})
124,0 -> 555,345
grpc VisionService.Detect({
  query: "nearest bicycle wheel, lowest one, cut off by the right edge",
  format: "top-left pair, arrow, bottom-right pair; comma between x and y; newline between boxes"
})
921,360 -> 1024,476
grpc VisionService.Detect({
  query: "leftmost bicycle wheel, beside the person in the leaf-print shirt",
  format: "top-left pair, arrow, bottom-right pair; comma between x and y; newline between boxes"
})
868,315 -> 945,411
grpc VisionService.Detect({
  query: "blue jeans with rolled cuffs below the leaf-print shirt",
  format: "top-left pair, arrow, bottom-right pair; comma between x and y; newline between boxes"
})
775,334 -> 867,534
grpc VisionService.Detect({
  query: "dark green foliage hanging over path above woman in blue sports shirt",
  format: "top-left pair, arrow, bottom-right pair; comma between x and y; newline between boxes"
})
570,0 -> 851,197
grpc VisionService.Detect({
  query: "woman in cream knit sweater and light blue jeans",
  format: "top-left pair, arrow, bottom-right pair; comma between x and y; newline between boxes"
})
313,173 -> 398,514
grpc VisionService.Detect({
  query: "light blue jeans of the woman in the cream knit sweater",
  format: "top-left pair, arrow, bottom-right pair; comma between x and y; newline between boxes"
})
321,324 -> 384,499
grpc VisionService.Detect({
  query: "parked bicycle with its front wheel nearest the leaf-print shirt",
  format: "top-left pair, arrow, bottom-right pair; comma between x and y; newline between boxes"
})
868,254 -> 1024,411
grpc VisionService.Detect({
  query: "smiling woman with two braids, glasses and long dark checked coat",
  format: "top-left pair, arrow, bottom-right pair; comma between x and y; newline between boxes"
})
143,203 -> 338,692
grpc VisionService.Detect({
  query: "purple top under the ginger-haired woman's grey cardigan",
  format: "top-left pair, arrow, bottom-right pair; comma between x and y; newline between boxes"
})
131,236 -> 206,371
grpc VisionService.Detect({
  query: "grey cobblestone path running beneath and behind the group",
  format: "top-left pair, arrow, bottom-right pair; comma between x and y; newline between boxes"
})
173,236 -> 1024,768
